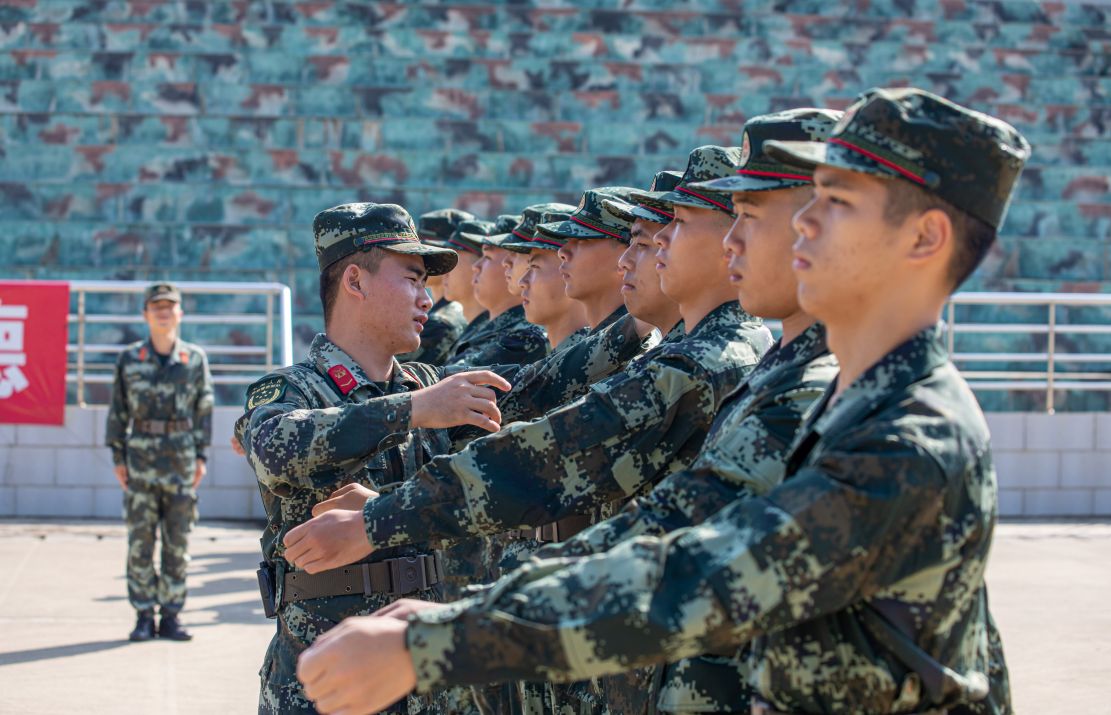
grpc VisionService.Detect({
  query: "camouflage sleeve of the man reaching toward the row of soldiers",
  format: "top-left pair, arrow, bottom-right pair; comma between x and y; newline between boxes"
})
237,383 -> 411,493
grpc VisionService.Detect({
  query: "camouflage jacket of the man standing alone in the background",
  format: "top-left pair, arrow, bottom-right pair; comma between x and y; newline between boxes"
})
104,339 -> 212,480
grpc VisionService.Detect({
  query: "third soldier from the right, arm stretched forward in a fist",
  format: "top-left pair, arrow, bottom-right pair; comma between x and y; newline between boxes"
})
282,147 -> 771,590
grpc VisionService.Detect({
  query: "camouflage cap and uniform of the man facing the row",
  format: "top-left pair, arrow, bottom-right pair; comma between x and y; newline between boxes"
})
236,204 -> 456,713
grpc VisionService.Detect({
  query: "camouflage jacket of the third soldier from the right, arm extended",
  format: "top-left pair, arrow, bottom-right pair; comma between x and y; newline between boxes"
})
363,302 -> 772,547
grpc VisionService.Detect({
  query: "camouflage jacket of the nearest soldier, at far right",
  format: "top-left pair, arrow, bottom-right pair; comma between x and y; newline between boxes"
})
408,329 -> 1009,714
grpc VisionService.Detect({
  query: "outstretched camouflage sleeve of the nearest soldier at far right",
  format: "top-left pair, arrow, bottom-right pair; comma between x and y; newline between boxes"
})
408,432 -> 944,689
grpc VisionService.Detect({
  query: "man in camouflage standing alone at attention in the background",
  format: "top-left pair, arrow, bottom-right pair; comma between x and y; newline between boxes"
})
104,283 -> 212,641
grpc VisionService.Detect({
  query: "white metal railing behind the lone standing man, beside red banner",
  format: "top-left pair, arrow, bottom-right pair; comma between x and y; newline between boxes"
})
66,281 -> 293,406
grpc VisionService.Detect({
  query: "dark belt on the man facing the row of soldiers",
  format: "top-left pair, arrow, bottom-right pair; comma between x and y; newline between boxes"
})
281,554 -> 443,605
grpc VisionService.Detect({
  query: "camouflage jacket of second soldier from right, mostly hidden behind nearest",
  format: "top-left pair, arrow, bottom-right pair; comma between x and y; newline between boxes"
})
551,324 -> 837,713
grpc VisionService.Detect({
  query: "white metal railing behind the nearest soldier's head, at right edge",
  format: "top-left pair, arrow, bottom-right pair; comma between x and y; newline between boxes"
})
945,292 -> 1111,414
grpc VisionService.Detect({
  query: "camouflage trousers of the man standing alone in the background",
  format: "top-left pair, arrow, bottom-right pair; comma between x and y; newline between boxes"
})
123,479 -> 197,614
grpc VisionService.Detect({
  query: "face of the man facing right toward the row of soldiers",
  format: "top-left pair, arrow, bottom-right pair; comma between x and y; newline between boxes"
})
359,252 -> 432,355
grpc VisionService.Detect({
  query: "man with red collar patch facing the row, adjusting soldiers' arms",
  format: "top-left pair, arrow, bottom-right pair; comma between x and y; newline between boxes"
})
236,203 -> 509,713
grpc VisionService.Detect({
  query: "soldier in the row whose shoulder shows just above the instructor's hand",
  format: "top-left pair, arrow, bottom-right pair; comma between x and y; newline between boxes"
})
448,221 -> 548,366
